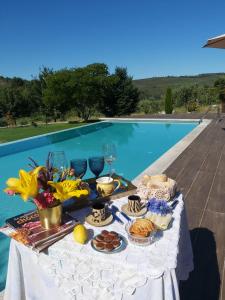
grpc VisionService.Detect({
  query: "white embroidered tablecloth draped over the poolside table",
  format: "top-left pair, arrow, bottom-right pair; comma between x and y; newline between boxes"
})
4,195 -> 193,300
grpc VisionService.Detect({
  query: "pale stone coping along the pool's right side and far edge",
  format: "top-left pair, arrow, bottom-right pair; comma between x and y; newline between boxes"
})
128,118 -> 212,185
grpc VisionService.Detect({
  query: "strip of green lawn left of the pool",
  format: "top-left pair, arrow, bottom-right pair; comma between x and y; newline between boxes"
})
0,123 -> 89,143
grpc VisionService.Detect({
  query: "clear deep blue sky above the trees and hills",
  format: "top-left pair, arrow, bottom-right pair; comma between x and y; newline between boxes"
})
0,0 -> 225,79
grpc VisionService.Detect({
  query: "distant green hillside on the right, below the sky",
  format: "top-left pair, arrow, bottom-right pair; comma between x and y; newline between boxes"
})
134,73 -> 225,99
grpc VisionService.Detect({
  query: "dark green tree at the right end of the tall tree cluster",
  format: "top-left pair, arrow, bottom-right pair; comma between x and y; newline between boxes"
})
100,67 -> 139,117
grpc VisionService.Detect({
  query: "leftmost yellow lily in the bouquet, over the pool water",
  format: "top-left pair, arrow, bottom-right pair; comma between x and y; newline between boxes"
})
4,167 -> 42,201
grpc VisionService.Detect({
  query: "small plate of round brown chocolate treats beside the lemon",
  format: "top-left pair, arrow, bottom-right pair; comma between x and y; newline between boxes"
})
92,230 -> 121,252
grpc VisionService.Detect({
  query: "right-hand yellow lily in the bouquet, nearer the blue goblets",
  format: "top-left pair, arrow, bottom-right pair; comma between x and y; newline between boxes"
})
48,180 -> 89,201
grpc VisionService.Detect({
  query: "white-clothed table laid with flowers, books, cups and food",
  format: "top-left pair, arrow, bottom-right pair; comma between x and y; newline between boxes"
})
1,151 -> 193,300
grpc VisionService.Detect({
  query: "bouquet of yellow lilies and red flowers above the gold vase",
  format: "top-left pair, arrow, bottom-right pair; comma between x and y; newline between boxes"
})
4,153 -> 89,209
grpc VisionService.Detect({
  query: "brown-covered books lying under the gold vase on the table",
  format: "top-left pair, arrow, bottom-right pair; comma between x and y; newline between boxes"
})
0,211 -> 79,252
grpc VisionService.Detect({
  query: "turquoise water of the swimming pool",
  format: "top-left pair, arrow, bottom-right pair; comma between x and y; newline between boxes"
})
0,122 -> 197,290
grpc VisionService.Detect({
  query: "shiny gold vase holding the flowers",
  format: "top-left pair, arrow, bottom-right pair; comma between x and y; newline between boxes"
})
38,203 -> 62,229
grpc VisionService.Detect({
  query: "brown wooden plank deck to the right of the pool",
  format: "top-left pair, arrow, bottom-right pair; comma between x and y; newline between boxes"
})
163,115 -> 225,300
